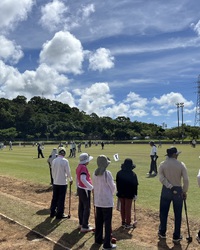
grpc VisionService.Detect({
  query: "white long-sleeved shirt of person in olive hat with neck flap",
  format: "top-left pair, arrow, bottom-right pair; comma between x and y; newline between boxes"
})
92,170 -> 116,207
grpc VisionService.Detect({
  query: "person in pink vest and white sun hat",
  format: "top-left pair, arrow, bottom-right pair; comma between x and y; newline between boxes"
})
76,153 -> 94,233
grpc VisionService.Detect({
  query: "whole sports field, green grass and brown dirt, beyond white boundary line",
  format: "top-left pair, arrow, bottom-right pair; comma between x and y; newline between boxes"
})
0,143 -> 200,250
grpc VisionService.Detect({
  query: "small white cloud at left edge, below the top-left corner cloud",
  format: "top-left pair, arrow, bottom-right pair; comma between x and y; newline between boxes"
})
0,35 -> 23,64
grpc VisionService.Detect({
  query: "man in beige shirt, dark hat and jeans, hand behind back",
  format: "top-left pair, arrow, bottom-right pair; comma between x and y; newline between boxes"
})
158,147 -> 189,242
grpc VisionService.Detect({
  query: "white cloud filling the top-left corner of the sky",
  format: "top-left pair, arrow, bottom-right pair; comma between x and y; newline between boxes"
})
0,0 -> 35,30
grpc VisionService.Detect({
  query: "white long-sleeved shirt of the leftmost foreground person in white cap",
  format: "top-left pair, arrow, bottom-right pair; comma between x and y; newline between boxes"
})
51,155 -> 73,185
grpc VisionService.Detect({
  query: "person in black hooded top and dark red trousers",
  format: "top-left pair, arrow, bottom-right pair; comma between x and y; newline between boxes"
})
116,158 -> 138,229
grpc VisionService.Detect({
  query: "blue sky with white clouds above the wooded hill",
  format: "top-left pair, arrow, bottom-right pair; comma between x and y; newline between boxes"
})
0,0 -> 200,128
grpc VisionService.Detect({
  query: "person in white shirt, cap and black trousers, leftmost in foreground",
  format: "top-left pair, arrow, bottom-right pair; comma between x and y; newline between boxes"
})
50,147 -> 73,219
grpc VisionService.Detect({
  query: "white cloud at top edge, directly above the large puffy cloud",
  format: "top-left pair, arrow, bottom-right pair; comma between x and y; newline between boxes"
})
40,0 -> 68,31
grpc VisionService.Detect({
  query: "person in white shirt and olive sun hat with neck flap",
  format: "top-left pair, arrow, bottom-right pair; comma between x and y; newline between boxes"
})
93,155 -> 116,249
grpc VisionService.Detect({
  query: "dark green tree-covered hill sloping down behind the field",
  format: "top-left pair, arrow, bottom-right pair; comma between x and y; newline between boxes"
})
0,96 -> 199,141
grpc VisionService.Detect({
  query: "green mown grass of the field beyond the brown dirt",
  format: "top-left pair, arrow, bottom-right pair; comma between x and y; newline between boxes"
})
0,144 -> 200,219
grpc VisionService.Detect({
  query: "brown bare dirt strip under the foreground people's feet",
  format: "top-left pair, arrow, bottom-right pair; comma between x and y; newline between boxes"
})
0,176 -> 200,250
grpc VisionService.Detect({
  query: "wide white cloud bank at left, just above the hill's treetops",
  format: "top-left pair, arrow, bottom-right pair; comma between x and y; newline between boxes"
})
0,61 -> 69,99
